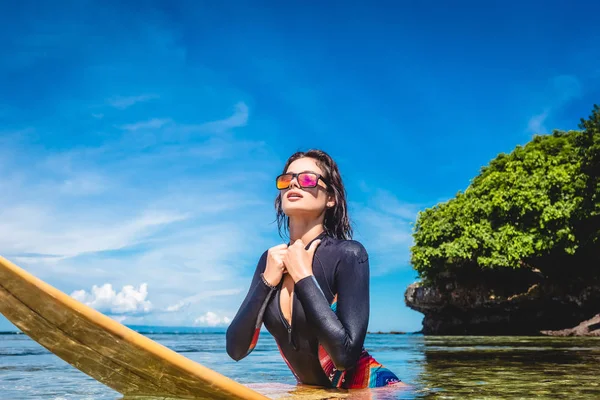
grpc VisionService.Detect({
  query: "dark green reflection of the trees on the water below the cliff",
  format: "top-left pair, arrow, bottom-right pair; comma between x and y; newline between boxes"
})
415,337 -> 600,399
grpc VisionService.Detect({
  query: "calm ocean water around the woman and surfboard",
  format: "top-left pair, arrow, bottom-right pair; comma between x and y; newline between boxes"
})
0,332 -> 600,400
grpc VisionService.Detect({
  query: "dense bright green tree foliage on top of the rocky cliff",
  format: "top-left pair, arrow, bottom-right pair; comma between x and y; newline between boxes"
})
411,105 -> 600,280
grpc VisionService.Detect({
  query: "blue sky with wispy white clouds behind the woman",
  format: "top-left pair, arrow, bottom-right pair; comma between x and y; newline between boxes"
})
0,1 -> 600,331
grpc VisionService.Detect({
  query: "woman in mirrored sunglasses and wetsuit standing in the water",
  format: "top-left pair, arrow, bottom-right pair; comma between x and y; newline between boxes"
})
227,150 -> 400,389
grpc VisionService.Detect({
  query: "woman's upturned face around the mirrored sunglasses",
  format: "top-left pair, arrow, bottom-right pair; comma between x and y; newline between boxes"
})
279,157 -> 335,218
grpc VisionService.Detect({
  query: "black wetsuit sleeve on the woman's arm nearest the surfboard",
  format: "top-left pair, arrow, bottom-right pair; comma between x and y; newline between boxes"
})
226,252 -> 275,361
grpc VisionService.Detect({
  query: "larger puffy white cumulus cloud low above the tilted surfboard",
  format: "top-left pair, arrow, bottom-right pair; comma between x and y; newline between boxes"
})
71,283 -> 152,315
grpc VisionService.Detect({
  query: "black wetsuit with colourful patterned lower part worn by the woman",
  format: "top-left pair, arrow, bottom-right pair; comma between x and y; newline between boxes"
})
227,233 -> 399,388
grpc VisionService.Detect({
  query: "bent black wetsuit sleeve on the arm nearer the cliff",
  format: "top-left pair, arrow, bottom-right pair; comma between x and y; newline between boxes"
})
294,241 -> 369,370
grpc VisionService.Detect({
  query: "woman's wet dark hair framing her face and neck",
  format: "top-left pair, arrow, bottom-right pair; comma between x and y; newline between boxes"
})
275,149 -> 352,239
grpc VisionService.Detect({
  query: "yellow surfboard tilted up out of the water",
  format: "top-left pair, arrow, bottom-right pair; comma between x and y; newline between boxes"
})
0,257 -> 267,400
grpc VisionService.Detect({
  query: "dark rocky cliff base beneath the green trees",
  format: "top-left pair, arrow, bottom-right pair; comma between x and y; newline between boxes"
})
405,276 -> 600,335
